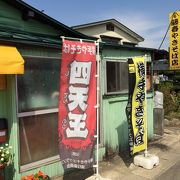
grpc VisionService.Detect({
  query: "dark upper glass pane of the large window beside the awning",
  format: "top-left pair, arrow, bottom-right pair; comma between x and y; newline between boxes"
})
17,59 -> 60,112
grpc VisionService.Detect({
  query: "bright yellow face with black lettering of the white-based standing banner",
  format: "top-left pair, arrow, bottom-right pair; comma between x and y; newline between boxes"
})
131,57 -> 147,154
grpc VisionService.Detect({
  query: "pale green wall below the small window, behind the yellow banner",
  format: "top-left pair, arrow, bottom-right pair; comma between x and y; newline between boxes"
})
103,94 -> 153,152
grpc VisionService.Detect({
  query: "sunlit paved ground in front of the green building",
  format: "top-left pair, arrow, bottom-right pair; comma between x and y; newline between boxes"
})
53,127 -> 180,180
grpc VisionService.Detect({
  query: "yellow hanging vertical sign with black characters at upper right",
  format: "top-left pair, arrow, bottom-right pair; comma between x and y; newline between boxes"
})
169,11 -> 180,70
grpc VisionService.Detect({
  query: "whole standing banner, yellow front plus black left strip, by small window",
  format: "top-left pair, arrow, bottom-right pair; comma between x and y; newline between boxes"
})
126,57 -> 147,155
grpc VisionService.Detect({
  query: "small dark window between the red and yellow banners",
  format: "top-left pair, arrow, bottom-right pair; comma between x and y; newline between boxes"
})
106,61 -> 128,93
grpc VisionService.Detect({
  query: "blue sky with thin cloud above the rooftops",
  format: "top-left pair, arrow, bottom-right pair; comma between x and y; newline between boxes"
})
24,0 -> 180,50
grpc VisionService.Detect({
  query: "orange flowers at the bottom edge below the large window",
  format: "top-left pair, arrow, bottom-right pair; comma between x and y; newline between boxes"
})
21,171 -> 50,180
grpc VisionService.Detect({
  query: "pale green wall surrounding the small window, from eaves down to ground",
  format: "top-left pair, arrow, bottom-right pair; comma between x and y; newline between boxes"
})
101,46 -> 153,152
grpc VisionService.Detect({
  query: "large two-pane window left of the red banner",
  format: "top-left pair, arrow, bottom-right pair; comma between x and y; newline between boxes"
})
17,59 -> 60,166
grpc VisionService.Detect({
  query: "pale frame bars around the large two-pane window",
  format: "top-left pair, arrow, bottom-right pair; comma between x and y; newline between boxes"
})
15,55 -> 61,172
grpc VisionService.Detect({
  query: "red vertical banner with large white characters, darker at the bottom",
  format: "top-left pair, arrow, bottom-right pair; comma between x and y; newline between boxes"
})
58,40 -> 96,169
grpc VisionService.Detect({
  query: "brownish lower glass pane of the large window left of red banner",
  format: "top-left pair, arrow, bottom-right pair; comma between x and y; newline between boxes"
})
19,113 -> 58,165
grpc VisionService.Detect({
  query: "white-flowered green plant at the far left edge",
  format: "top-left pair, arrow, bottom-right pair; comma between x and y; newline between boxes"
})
0,143 -> 13,169
